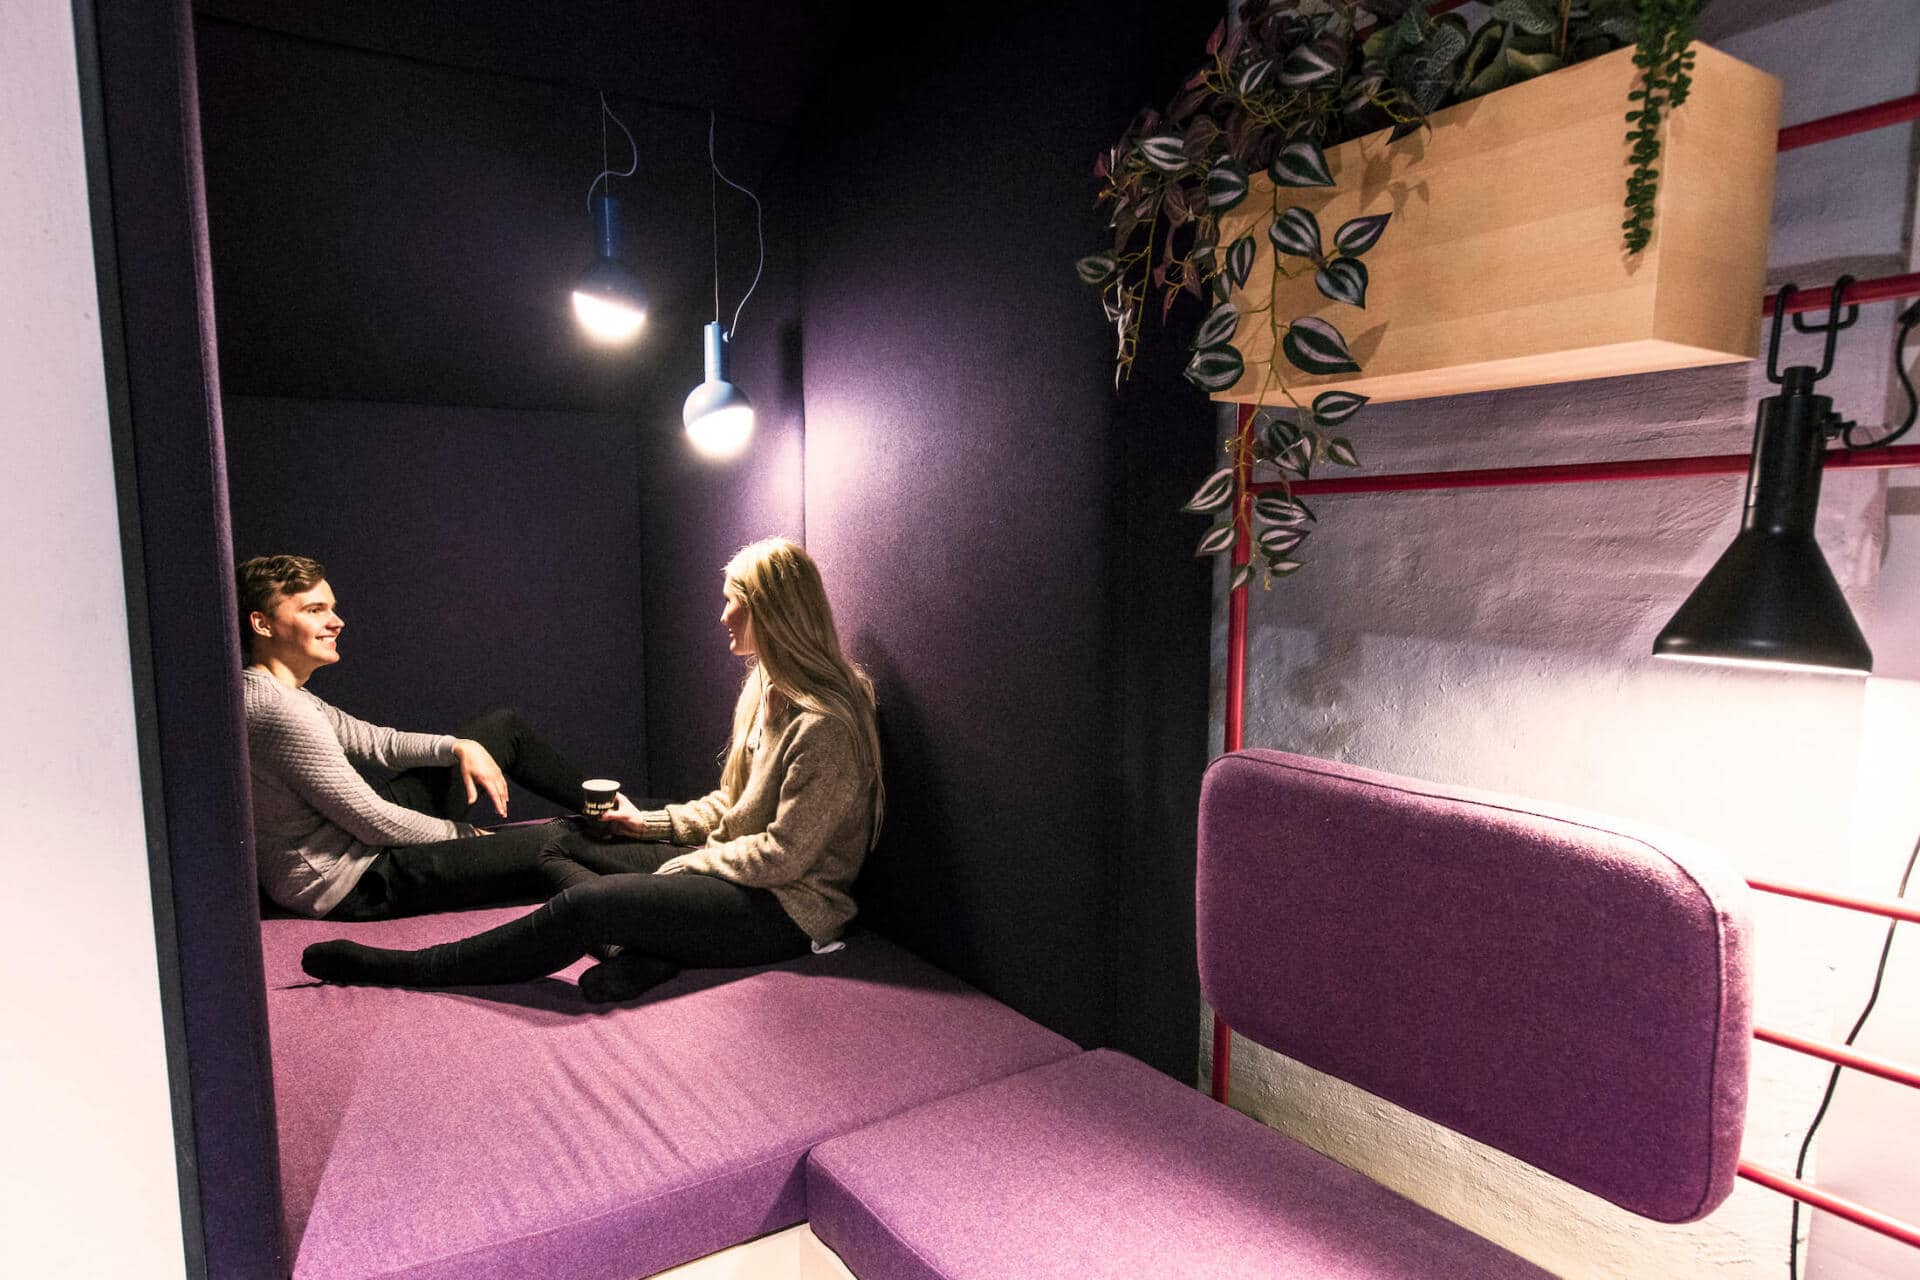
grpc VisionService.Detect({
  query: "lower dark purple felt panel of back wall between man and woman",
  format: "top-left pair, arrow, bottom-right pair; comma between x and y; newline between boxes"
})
227,395 -> 647,794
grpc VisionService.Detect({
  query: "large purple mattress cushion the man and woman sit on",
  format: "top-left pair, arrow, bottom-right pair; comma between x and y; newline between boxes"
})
263,908 -> 1073,1280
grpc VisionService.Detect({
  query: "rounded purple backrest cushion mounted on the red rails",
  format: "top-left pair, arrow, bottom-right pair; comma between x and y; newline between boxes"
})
1198,750 -> 1751,1222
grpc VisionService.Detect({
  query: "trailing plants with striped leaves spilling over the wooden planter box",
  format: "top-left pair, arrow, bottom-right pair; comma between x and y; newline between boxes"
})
1075,0 -> 1705,587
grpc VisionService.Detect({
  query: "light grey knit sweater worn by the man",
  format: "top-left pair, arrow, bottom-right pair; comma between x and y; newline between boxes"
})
242,668 -> 474,915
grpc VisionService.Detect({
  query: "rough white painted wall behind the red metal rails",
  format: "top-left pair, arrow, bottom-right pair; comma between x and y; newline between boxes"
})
1196,0 -> 1920,1280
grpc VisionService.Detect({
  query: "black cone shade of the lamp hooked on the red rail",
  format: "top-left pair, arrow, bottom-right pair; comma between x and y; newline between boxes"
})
1653,530 -> 1874,676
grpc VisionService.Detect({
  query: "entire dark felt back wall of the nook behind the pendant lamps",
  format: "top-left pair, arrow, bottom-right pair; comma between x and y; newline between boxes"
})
198,6 -> 801,794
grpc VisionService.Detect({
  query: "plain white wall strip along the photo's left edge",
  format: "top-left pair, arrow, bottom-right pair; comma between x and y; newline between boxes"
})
0,0 -> 184,1280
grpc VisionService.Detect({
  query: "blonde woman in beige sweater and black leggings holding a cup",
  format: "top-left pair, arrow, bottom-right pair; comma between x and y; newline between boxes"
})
301,539 -> 885,1000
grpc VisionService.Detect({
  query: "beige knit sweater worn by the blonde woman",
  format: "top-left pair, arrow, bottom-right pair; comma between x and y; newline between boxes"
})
641,710 -> 874,944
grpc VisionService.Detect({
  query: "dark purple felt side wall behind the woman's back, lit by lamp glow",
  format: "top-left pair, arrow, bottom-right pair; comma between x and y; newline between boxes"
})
795,4 -> 1215,1075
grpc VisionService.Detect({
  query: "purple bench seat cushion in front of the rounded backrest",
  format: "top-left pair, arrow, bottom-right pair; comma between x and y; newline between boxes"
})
806,1050 -> 1548,1280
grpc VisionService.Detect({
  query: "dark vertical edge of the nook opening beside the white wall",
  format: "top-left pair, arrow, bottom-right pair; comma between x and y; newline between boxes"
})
75,0 -> 288,1280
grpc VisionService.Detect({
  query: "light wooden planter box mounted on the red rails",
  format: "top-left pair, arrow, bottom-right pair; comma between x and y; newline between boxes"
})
1215,44 -> 1780,403
